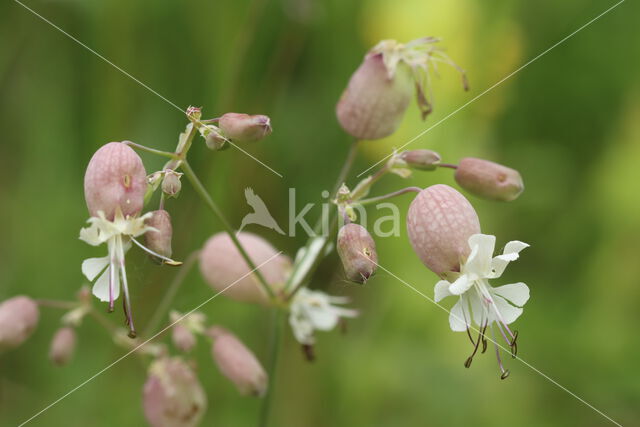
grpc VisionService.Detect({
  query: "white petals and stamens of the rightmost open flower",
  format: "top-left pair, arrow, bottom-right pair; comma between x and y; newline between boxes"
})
434,234 -> 529,378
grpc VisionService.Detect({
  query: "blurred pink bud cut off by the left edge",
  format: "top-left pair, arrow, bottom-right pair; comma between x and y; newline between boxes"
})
0,295 -> 40,351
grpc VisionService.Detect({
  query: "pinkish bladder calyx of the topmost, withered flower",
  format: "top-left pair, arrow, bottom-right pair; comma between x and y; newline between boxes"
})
336,53 -> 415,139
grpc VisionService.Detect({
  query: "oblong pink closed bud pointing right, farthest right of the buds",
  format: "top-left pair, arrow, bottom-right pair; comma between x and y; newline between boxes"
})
455,157 -> 524,202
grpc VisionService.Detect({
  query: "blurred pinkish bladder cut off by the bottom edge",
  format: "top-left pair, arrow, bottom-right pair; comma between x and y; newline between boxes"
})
143,357 -> 207,427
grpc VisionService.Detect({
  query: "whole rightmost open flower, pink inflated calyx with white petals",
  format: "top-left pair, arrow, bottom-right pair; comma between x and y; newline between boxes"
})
407,185 -> 529,379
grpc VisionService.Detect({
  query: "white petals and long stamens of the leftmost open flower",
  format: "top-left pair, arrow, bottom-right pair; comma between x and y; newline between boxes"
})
80,209 -> 180,335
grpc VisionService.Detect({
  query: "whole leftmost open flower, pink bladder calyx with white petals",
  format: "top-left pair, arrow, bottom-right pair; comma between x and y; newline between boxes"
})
80,142 -> 180,337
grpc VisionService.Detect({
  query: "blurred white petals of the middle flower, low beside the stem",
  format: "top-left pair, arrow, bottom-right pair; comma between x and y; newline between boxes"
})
289,288 -> 358,345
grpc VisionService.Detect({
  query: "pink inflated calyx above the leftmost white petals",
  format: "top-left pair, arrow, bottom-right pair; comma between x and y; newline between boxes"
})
84,142 -> 147,220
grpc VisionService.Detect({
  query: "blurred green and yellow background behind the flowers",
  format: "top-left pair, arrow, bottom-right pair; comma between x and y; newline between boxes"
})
0,0 -> 640,426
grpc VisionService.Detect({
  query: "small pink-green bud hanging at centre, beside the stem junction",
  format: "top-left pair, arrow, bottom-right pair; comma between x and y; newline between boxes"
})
336,223 -> 378,283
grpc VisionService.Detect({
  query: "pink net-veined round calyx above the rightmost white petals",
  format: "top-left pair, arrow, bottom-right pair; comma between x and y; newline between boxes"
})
407,184 -> 480,276
